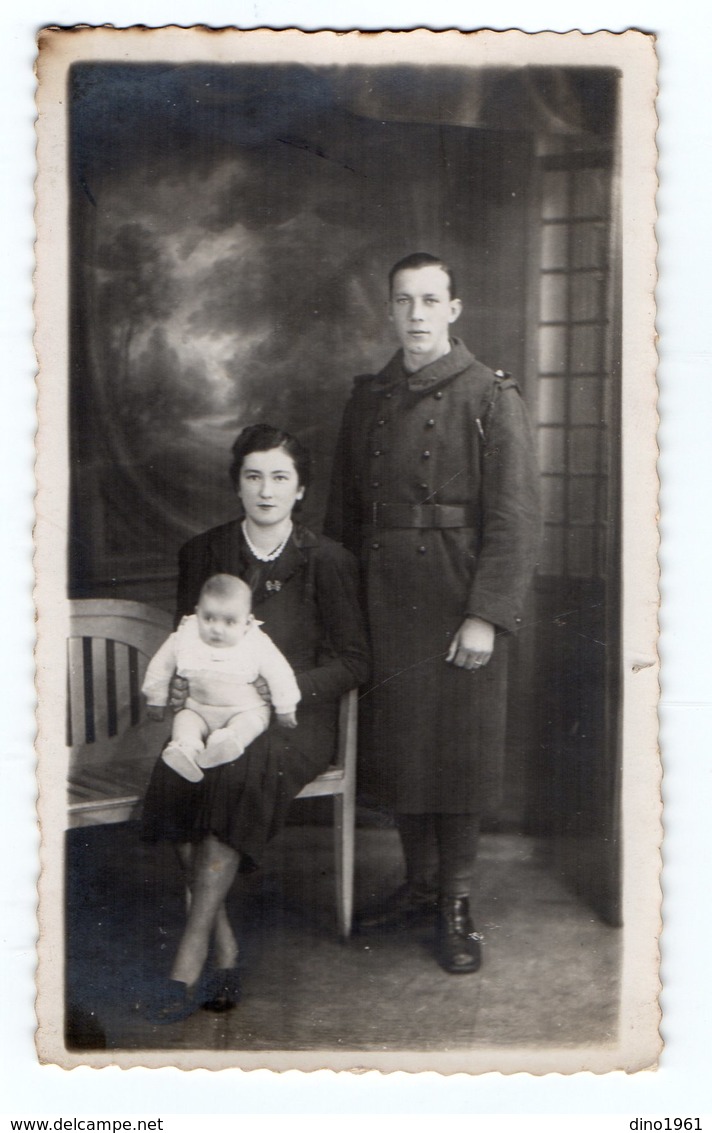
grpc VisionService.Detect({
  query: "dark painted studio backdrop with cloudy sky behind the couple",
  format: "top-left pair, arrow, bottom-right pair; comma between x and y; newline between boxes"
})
68,63 -> 620,922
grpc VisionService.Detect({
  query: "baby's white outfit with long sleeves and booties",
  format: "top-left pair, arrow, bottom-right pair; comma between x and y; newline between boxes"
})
142,614 -> 300,783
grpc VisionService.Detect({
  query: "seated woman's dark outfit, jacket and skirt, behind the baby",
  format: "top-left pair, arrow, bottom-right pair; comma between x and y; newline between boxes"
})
143,520 -> 368,863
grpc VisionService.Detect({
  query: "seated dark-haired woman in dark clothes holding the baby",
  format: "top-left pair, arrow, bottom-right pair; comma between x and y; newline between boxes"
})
143,425 -> 368,1023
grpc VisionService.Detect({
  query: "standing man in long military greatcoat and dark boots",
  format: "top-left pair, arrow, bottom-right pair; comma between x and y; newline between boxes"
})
325,253 -> 539,973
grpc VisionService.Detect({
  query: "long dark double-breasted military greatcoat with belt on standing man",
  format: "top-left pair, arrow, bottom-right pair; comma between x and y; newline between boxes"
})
325,339 -> 540,813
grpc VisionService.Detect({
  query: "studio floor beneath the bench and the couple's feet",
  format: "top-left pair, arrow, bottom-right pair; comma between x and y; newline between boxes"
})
66,823 -> 620,1064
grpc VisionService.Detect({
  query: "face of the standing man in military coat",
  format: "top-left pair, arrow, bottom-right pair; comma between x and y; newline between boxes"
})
389,264 -> 463,368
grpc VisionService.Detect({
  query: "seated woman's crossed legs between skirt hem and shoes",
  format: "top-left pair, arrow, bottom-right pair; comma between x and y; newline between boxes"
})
170,834 -> 239,988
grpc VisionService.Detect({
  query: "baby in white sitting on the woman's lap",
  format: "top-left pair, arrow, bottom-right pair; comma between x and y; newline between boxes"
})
142,574 -> 300,783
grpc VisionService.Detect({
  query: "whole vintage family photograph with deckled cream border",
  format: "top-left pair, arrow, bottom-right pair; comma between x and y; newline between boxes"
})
36,28 -> 660,1073
